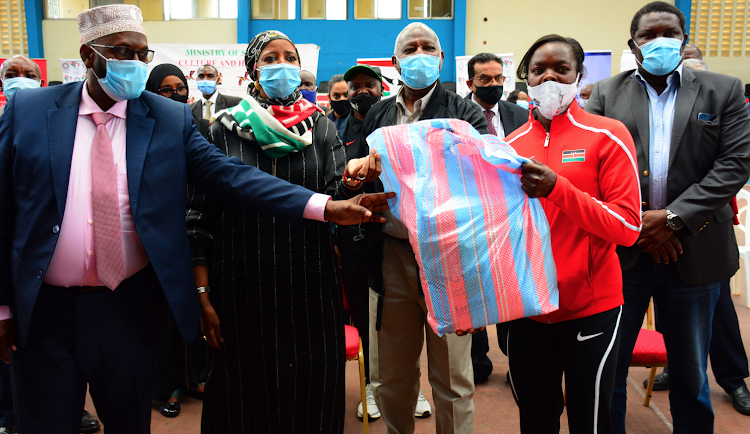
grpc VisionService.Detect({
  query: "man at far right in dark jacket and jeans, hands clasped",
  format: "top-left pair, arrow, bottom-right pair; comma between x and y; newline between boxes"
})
586,2 -> 750,433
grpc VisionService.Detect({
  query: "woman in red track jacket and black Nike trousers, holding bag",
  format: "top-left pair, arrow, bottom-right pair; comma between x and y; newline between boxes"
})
506,35 -> 641,434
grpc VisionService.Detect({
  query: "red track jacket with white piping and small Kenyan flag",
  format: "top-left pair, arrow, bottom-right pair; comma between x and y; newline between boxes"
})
506,101 -> 641,323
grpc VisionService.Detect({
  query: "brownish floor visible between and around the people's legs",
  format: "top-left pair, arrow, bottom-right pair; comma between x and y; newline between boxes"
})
78,285 -> 750,434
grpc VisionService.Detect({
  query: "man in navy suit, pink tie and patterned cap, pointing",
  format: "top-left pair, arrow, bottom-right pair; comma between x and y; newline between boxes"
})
0,5 -> 396,434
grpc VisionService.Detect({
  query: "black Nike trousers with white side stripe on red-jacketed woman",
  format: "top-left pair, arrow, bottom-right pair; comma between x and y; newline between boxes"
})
508,307 -> 622,434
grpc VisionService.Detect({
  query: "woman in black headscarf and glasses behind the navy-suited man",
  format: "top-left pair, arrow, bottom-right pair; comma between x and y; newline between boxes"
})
146,63 -> 209,417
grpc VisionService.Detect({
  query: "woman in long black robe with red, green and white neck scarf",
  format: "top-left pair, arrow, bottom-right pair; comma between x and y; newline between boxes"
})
187,31 -> 374,434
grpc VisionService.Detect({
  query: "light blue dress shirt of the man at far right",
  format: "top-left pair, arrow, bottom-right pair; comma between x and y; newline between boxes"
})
635,64 -> 682,209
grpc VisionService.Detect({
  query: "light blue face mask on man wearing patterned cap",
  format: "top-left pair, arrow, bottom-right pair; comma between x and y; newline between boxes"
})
94,50 -> 148,101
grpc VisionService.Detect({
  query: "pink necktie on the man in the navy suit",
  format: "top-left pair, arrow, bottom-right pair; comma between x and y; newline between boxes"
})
91,112 -> 125,290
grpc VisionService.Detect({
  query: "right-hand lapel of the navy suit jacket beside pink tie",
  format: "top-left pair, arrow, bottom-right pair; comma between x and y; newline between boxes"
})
125,97 -> 155,217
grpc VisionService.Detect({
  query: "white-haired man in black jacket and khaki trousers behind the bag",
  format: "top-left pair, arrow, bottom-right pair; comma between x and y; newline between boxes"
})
363,23 -> 487,433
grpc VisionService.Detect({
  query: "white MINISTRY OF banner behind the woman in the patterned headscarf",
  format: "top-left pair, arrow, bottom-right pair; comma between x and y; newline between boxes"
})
148,44 -> 320,101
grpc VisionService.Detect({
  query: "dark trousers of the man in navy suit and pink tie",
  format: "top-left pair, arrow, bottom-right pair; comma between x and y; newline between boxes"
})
10,265 -> 168,434
